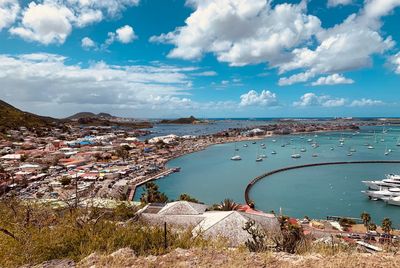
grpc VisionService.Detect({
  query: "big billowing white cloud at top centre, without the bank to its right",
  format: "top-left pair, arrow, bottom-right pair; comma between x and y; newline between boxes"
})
150,0 -> 320,66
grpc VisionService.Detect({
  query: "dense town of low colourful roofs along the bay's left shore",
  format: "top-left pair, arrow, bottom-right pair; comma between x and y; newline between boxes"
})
0,117 -> 364,203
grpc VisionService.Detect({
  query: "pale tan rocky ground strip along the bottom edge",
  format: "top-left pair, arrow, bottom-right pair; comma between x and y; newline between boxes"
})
24,248 -> 400,268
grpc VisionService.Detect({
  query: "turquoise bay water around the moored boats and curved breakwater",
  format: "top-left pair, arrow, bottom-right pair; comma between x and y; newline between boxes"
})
136,127 -> 400,225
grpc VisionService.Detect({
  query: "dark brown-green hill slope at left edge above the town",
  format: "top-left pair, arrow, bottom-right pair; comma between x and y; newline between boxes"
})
0,100 -> 58,132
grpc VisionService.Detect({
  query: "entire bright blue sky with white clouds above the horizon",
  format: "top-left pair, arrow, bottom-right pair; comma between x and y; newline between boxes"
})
0,0 -> 400,118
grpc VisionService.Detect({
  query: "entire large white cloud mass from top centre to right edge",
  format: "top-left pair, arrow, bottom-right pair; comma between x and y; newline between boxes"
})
150,0 -> 400,85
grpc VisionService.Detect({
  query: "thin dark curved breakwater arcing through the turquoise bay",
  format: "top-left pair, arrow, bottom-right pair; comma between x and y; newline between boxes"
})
244,160 -> 400,205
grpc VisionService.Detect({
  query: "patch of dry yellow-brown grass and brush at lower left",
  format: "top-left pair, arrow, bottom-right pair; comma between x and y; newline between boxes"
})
0,199 -> 211,267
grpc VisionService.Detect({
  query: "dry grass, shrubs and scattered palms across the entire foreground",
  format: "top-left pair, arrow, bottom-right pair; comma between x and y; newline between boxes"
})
0,183 -> 398,267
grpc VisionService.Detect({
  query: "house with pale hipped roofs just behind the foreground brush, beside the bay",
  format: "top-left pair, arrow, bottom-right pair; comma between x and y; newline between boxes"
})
139,201 -> 279,246
